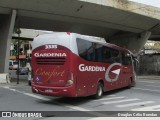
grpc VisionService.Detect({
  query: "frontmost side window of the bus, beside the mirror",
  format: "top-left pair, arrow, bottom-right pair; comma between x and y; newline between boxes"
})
122,52 -> 132,65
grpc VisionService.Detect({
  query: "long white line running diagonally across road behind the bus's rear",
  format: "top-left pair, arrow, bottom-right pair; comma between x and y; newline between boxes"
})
3,87 -> 106,117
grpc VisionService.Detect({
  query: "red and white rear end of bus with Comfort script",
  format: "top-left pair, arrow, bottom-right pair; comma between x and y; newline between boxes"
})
32,34 -> 76,97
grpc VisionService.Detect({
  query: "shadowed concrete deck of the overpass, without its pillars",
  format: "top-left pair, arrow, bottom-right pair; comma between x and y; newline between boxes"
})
0,0 -> 160,40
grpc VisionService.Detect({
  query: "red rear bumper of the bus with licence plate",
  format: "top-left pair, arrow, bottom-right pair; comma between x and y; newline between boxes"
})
32,84 -> 77,97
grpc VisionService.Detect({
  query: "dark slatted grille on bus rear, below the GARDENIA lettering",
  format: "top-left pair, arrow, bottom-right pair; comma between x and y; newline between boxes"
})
36,58 -> 66,65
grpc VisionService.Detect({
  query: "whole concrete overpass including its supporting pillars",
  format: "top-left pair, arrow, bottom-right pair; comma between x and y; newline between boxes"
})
0,0 -> 160,73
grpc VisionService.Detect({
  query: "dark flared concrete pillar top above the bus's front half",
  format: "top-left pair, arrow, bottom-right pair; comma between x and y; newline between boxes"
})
110,31 -> 151,53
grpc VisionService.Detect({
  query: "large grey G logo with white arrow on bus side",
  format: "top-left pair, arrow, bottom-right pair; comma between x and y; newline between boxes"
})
105,63 -> 122,82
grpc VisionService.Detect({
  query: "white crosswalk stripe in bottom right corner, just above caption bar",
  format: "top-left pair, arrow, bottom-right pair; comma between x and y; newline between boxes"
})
132,105 -> 160,111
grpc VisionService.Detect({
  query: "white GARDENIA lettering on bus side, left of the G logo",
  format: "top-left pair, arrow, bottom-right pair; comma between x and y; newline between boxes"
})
79,64 -> 106,71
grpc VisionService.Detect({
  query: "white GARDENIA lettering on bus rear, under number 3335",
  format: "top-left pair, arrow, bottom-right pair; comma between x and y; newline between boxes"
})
34,53 -> 67,57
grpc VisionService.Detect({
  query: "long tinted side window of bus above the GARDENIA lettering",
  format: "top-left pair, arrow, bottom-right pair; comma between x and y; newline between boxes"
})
77,39 -> 121,63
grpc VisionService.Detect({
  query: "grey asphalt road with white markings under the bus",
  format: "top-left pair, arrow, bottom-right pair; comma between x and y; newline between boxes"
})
0,78 -> 160,120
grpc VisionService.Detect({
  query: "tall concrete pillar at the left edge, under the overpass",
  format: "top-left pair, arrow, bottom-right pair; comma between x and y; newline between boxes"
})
0,10 -> 16,73
